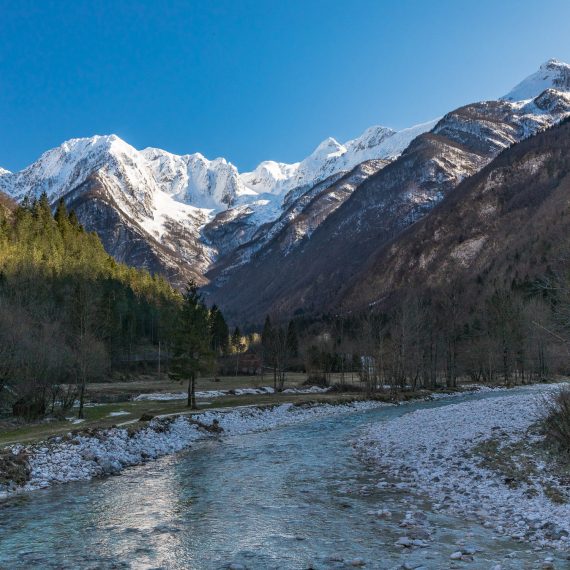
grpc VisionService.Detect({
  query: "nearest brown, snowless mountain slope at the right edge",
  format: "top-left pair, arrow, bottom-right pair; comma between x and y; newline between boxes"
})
339,116 -> 570,310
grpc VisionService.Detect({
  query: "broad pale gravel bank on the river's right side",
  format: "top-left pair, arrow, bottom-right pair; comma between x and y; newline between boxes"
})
357,385 -> 570,549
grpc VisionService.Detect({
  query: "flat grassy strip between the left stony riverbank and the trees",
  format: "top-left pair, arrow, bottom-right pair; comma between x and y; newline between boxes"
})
0,373 -> 364,447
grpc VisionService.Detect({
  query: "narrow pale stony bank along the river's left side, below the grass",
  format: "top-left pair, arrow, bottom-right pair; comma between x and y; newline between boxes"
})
0,402 -> 387,498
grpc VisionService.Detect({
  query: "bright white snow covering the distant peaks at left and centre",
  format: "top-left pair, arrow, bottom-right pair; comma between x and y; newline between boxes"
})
0,116 -> 434,263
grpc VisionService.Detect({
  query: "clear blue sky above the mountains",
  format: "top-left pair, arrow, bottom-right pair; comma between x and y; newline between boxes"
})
0,0 -> 570,170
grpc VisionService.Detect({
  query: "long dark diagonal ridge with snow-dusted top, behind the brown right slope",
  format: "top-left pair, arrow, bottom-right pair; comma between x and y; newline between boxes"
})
208,89 -> 570,322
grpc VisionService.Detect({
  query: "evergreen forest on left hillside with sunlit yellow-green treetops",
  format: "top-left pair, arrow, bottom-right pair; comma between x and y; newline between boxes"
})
0,195 -> 233,418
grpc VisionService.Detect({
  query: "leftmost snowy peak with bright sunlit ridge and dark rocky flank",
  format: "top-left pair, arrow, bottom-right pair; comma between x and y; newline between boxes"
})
0,135 -> 220,286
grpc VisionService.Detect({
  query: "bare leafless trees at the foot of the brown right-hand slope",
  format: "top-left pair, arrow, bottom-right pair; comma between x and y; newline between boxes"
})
274,273 -> 570,393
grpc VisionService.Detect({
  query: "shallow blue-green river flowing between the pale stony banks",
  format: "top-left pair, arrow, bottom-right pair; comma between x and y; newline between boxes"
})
0,394 -> 568,570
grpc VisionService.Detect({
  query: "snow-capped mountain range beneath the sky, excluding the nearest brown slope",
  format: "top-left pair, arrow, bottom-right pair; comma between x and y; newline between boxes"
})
0,60 -> 570,323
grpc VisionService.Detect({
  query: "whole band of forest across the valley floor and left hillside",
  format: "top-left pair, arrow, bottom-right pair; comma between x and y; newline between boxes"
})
0,186 -> 570,418
